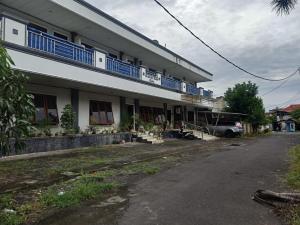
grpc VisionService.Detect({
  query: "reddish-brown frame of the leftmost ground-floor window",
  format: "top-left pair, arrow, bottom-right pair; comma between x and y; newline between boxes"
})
32,93 -> 59,126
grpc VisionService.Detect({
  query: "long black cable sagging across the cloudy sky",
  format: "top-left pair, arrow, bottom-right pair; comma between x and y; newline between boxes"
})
153,0 -> 299,81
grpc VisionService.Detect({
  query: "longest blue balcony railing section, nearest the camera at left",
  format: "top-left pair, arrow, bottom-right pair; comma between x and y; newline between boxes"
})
27,27 -> 94,65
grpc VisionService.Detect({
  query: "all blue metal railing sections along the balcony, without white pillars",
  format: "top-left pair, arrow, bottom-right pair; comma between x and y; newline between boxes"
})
27,27 -> 211,97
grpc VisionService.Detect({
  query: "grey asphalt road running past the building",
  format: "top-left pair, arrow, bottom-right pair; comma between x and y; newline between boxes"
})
119,134 -> 300,225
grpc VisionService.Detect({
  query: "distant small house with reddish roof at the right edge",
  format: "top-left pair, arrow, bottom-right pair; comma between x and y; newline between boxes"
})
269,104 -> 300,132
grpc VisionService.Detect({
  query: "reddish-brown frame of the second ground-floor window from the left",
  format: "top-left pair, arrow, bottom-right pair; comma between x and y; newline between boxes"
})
89,100 -> 115,126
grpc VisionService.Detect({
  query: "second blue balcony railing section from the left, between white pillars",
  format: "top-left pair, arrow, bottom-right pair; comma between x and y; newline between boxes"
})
106,56 -> 140,79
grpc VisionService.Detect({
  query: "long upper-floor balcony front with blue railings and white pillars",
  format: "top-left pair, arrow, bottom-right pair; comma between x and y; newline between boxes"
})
2,21 -> 211,98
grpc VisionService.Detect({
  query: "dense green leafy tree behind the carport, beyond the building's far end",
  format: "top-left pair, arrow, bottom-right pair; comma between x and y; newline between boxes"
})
225,81 -> 266,130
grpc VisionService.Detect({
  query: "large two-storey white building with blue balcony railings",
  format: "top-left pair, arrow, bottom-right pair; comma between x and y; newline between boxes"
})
0,0 -> 213,130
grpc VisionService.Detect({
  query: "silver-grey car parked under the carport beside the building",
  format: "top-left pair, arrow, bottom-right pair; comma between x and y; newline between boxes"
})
205,122 -> 244,137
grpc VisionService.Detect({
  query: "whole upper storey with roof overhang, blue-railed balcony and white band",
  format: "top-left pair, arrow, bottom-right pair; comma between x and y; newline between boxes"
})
0,0 -> 216,105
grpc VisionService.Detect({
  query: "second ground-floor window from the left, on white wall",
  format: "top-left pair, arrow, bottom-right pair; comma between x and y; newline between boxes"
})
90,101 -> 114,125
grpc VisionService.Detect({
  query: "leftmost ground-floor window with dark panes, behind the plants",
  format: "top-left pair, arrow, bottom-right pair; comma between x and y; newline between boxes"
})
33,94 -> 59,125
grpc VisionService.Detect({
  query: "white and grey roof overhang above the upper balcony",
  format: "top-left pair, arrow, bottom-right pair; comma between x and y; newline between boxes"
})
1,0 -> 212,82
